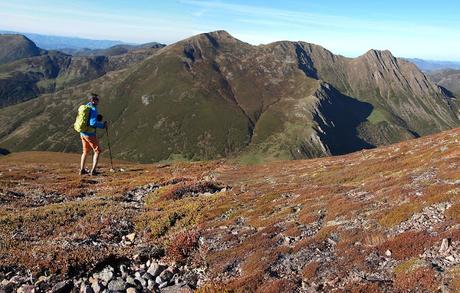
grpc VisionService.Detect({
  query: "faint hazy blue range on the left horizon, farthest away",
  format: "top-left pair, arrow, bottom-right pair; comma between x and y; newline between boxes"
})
0,31 -> 126,50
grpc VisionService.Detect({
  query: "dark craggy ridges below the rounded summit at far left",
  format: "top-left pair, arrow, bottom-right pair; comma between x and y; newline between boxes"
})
0,38 -> 162,107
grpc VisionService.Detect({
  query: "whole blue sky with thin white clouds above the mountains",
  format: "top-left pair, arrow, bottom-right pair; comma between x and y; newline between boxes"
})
0,0 -> 460,61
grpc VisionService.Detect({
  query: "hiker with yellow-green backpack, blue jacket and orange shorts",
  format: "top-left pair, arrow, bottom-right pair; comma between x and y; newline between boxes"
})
74,93 -> 107,176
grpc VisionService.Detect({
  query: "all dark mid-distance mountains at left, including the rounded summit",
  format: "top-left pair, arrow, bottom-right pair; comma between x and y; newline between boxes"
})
0,35 -> 164,108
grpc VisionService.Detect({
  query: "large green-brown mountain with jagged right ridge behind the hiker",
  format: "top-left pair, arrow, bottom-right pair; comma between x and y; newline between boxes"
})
0,31 -> 460,162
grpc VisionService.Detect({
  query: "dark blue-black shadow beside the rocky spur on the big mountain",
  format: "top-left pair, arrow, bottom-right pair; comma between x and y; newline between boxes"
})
313,84 -> 375,155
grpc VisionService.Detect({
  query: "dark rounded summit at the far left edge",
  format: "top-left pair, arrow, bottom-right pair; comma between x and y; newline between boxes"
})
0,35 -> 43,64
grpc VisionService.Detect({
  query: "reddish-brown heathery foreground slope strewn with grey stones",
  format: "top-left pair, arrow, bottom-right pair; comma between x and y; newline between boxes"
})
0,129 -> 460,292
